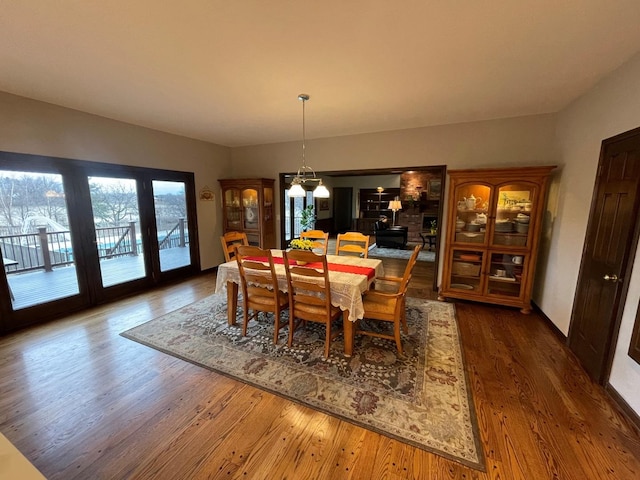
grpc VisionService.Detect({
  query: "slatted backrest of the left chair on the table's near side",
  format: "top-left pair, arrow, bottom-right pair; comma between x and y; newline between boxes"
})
235,245 -> 278,305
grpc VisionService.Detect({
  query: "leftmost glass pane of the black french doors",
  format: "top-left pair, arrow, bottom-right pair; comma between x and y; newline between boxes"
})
0,170 -> 79,310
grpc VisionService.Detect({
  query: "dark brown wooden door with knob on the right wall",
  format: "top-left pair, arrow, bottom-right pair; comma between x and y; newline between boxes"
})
569,129 -> 640,383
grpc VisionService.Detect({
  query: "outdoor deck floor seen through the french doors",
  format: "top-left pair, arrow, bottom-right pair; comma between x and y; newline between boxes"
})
7,248 -> 191,310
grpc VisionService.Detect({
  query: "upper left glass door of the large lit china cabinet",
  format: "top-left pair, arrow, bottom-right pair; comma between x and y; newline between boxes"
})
455,183 -> 491,244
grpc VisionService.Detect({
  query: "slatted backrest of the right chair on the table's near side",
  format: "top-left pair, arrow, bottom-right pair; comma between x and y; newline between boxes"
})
282,250 -> 331,322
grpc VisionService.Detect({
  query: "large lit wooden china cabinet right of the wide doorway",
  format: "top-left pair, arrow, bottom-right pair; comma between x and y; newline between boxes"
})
439,166 -> 555,313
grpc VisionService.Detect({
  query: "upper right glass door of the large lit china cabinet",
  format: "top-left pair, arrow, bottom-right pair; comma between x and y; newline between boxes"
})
491,183 -> 536,247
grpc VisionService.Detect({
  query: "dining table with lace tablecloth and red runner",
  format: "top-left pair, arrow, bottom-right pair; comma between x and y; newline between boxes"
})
216,249 -> 384,357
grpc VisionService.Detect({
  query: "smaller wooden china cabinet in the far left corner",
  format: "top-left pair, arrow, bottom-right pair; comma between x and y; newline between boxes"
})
220,178 -> 276,248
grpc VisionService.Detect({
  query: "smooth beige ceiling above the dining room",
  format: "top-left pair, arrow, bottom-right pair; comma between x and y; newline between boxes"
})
0,0 -> 640,147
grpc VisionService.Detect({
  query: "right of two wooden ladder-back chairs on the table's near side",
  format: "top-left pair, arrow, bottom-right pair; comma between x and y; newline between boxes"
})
282,250 -> 342,358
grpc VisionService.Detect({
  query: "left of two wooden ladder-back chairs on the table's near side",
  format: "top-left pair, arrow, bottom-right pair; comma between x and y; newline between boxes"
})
235,245 -> 289,344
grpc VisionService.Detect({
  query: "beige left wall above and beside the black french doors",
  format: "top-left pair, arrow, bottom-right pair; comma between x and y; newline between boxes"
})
0,92 -> 230,269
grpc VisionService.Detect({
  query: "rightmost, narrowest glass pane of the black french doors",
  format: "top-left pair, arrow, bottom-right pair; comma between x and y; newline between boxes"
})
152,180 -> 191,272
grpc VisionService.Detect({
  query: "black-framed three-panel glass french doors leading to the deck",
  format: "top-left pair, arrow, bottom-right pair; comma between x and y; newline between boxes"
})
0,152 -> 199,333
